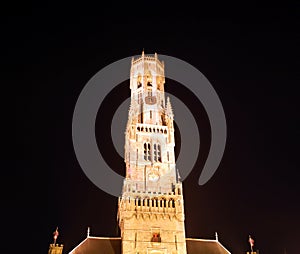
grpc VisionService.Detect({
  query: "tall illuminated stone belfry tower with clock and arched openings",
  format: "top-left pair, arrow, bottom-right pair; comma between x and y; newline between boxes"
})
118,52 -> 186,254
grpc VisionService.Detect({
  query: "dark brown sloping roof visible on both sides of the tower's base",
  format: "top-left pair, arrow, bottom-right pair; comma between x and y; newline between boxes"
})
70,236 -> 230,254
